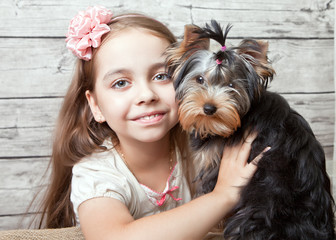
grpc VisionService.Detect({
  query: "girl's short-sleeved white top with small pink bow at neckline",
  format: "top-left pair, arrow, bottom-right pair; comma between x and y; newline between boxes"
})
70,142 -> 191,224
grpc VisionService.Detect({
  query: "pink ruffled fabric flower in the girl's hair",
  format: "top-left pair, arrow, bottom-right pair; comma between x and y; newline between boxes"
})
65,6 -> 113,61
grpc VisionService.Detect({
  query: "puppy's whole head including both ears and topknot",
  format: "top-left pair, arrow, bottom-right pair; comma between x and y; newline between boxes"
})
167,21 -> 274,138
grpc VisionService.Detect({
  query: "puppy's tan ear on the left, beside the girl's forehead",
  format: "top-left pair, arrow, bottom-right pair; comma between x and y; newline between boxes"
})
166,24 -> 210,76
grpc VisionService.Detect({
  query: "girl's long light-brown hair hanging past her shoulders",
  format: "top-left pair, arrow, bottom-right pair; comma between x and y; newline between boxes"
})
39,14 -> 191,228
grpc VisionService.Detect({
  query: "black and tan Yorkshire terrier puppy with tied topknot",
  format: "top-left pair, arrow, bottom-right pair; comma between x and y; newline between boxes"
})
167,21 -> 335,240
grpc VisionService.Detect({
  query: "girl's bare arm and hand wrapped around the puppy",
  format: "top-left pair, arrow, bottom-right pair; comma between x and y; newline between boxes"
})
78,137 -> 261,240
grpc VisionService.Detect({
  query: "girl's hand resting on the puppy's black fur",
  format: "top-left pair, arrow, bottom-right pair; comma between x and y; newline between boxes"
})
214,133 -> 270,207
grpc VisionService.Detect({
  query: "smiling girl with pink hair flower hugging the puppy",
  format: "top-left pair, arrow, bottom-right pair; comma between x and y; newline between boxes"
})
40,7 -> 262,239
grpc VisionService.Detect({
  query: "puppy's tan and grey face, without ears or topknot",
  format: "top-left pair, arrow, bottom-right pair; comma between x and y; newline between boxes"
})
174,50 -> 258,138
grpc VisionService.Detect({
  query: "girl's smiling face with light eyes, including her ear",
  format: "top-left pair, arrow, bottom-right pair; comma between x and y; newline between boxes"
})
86,28 -> 178,142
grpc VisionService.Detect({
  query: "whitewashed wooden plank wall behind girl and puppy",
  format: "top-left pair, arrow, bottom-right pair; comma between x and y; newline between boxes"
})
0,0 -> 336,230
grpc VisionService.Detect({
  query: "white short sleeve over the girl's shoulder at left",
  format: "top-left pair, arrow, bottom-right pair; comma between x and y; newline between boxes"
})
70,140 -> 136,222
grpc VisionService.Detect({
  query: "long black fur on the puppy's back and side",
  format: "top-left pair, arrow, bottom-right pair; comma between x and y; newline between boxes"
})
218,91 -> 335,240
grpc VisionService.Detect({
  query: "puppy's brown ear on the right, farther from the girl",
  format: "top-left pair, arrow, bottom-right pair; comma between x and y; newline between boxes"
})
238,40 -> 275,85
